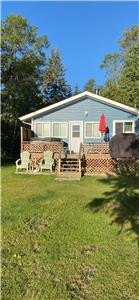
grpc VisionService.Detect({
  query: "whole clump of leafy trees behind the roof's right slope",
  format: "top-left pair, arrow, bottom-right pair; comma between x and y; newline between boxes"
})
100,25 -> 139,106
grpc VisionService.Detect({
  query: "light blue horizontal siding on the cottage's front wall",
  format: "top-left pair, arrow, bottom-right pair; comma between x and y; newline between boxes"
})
32,98 -> 139,143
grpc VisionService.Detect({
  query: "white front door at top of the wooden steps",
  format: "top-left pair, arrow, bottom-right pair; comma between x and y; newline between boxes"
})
69,121 -> 83,153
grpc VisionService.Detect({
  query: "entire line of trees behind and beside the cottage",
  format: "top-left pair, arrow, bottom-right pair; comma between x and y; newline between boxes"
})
1,15 -> 139,160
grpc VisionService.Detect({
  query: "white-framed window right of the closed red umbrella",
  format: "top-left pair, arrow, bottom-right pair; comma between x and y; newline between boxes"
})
113,121 -> 134,134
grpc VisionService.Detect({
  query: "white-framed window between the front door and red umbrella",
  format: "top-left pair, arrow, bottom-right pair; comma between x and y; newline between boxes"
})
85,122 -> 100,138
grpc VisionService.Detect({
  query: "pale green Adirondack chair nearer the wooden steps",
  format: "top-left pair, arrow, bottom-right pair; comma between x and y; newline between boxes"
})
40,151 -> 54,173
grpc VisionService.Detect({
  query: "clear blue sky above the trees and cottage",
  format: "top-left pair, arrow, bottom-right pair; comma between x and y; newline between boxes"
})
2,1 -> 139,89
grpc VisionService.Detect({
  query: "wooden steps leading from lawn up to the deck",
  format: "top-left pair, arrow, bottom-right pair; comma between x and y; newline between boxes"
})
57,155 -> 81,180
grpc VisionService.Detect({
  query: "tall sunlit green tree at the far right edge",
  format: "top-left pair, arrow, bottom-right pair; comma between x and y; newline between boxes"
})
120,26 -> 139,107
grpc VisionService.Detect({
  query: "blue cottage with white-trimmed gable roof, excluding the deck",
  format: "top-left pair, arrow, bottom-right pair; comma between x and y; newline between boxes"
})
19,91 -> 139,153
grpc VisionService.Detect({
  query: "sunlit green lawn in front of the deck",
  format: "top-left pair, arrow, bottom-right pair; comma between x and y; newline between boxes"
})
2,166 -> 139,300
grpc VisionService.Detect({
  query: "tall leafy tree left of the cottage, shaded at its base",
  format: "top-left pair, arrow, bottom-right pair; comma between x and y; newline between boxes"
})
1,15 -> 48,162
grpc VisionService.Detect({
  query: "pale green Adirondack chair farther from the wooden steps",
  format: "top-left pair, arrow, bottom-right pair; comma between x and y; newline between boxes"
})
16,151 -> 30,172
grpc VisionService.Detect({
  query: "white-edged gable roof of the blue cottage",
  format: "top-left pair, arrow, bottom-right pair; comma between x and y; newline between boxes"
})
19,91 -> 138,121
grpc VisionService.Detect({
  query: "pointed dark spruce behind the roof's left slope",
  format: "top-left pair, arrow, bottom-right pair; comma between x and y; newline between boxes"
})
43,48 -> 71,104
